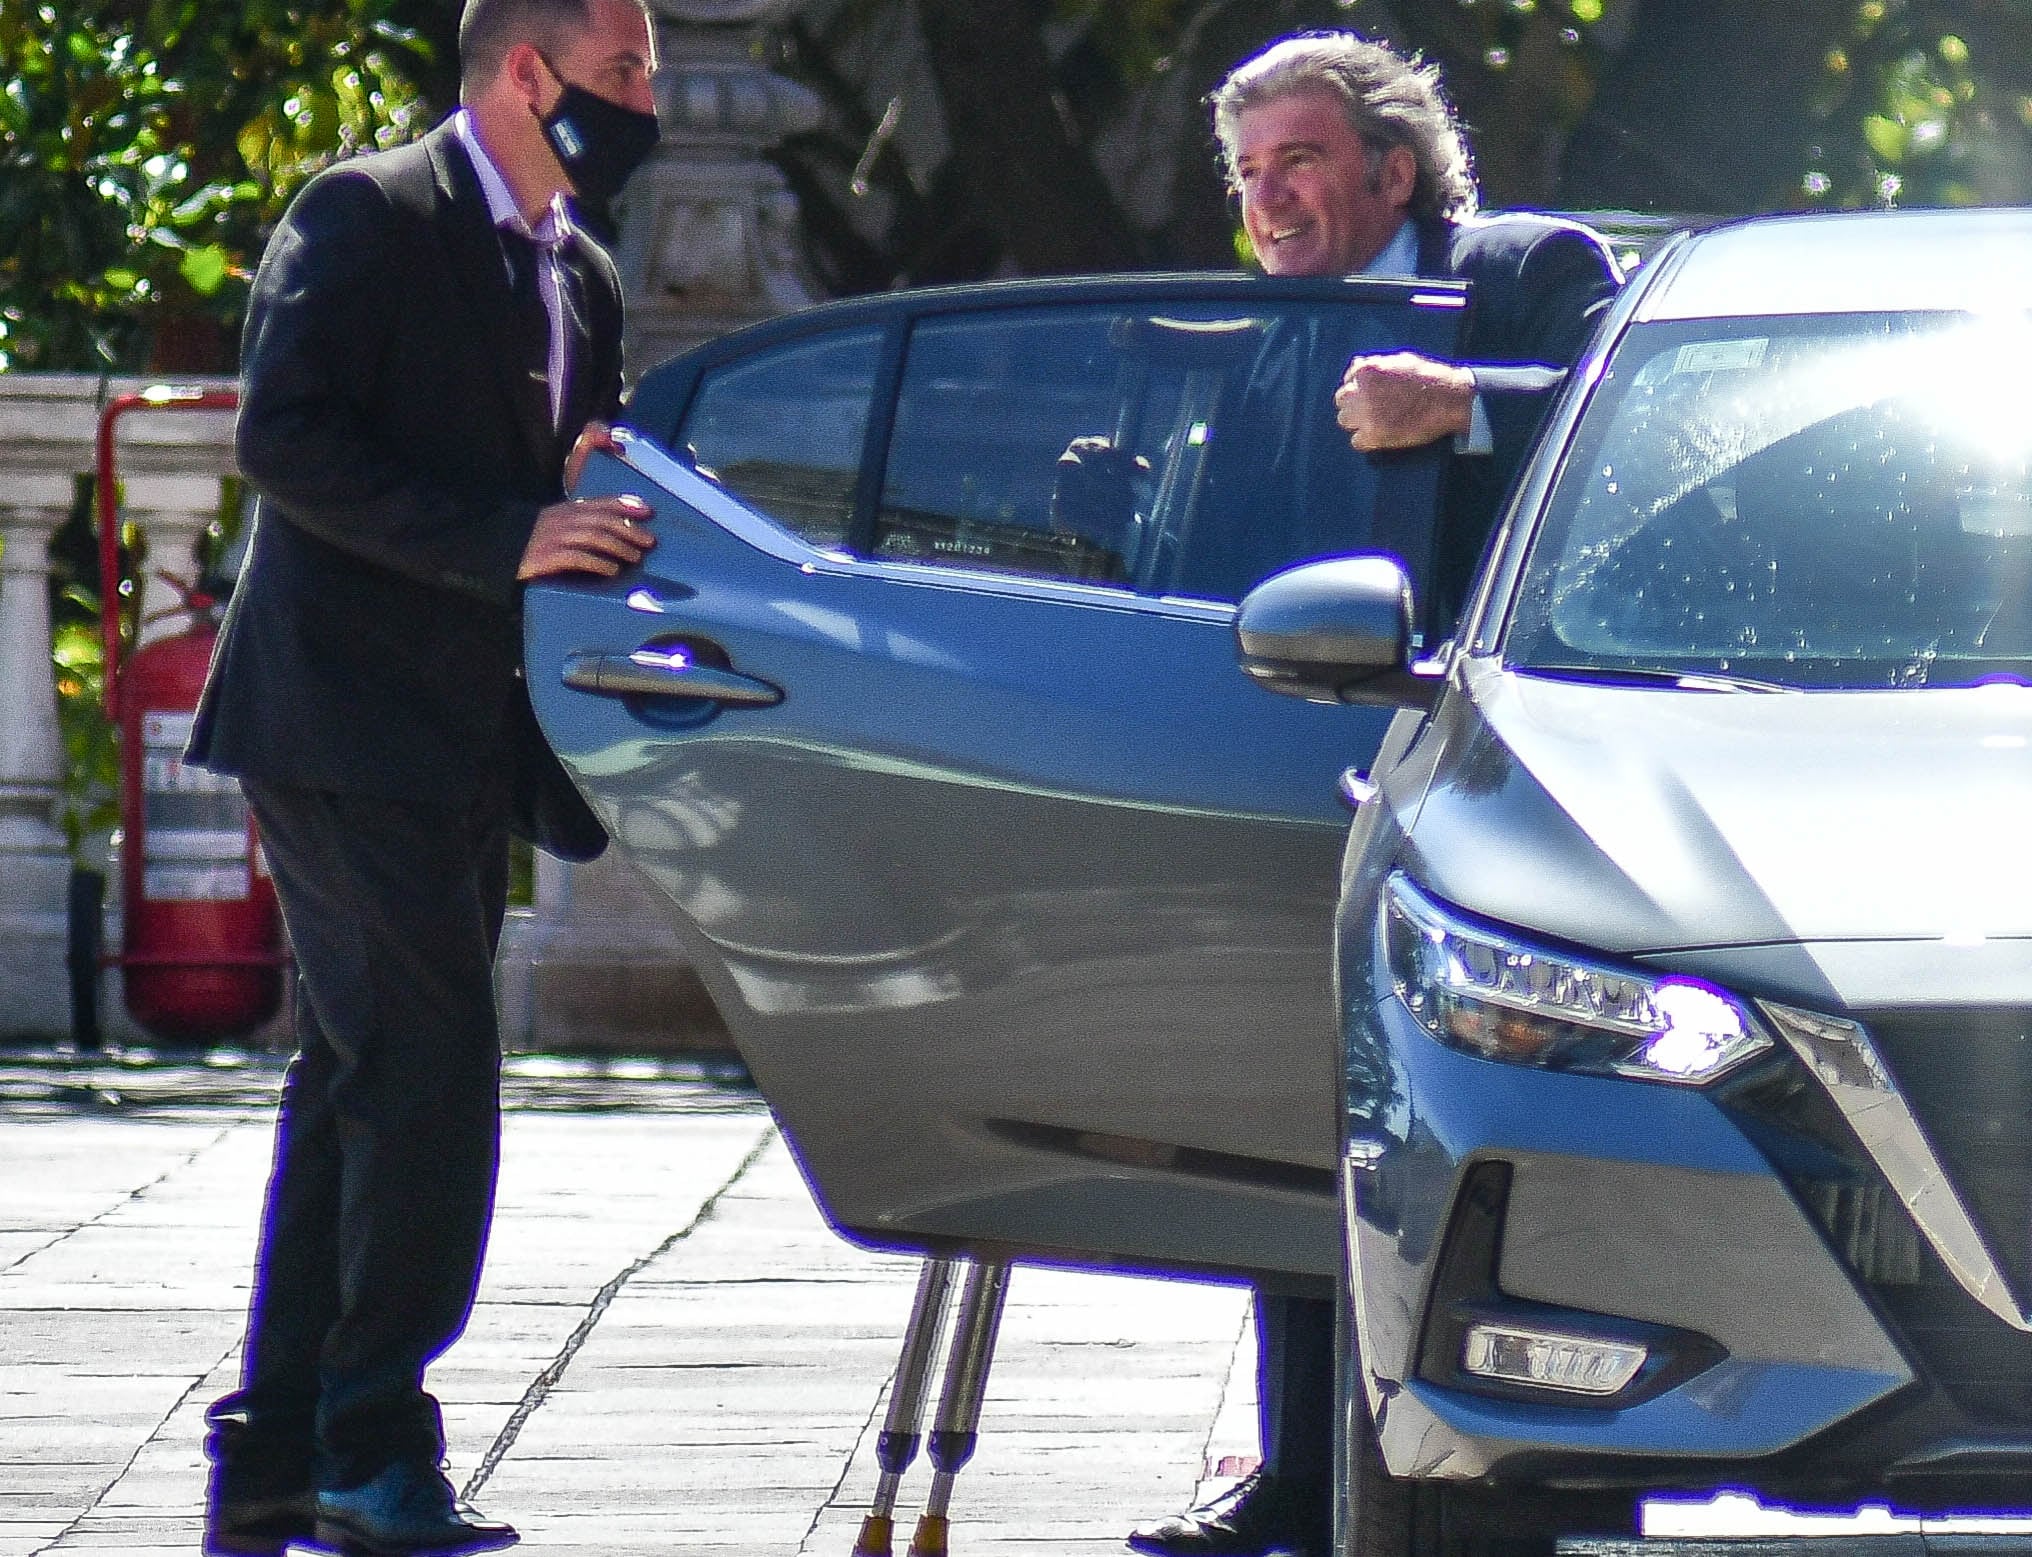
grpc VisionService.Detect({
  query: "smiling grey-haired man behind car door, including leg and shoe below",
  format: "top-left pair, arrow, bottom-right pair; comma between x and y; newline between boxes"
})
1130,33 -> 1622,1557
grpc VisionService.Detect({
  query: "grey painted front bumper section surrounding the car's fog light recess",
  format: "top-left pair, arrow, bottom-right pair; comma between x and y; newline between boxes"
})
1345,996 -> 1914,1486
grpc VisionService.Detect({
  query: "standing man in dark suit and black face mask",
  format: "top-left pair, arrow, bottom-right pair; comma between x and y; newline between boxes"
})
189,0 -> 656,1557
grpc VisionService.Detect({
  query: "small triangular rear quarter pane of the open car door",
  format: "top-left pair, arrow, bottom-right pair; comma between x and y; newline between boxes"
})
675,329 -> 882,547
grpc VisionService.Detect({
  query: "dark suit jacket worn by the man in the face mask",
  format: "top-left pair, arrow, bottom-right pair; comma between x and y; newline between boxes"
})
189,124 -> 622,856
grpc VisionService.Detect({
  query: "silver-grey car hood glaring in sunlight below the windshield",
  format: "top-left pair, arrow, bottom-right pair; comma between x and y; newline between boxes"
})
1406,667 -> 2032,953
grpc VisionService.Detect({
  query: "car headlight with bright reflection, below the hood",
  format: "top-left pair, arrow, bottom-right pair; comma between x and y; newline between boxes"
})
1382,872 -> 1772,1085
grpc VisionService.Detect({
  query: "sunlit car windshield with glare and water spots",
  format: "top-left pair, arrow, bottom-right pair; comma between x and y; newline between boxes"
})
1504,313 -> 2032,687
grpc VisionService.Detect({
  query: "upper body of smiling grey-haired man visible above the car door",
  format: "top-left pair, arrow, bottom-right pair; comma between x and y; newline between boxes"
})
1209,33 -> 1622,624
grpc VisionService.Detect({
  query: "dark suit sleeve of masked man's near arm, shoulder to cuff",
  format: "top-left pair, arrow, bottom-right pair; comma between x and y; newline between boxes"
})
236,171 -> 538,604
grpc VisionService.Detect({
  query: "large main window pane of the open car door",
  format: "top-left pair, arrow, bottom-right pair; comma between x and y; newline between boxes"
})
874,301 -> 1446,600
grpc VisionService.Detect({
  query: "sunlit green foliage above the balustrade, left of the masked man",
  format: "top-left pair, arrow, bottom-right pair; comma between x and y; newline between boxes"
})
0,0 -> 455,372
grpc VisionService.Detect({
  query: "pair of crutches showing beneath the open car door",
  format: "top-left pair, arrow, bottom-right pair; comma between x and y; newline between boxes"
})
853,1258 -> 1010,1557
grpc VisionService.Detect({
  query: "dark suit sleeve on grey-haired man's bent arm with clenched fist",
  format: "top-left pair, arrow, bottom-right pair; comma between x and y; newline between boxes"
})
1467,226 -> 1622,474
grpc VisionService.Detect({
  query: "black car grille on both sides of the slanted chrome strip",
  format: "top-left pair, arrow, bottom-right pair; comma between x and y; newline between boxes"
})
1723,1010 -> 2032,1431
